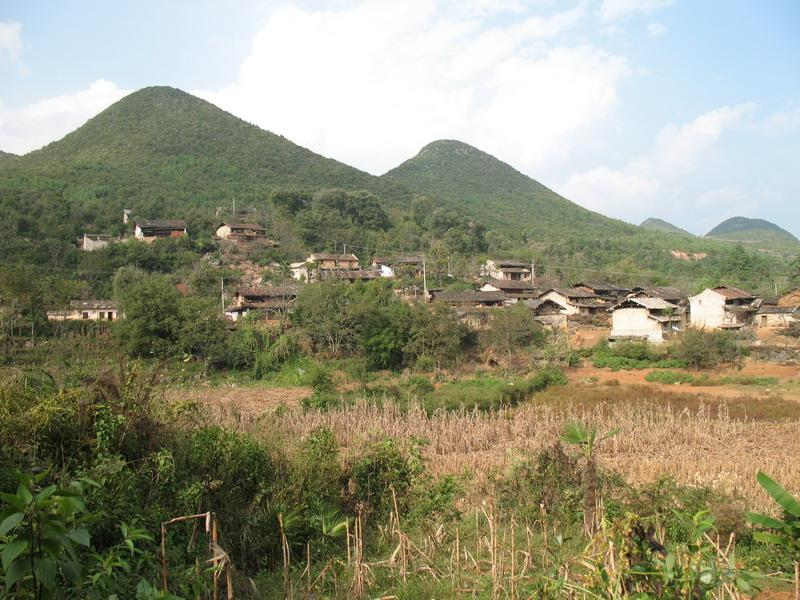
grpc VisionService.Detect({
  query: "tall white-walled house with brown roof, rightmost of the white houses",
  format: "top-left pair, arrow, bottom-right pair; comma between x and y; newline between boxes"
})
689,285 -> 760,329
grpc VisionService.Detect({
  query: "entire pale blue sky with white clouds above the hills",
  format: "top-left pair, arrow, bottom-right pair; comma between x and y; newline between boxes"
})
0,0 -> 800,236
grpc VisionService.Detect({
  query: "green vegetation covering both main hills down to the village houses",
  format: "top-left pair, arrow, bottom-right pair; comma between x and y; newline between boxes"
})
0,87 -> 796,291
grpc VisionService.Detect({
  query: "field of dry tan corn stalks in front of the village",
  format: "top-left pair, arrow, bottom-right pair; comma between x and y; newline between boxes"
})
208,392 -> 800,510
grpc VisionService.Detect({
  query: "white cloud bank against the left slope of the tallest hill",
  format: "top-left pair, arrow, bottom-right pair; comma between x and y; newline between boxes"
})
0,79 -> 128,154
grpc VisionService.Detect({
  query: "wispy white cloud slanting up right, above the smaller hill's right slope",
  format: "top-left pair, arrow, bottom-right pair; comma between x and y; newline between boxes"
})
560,102 -> 755,223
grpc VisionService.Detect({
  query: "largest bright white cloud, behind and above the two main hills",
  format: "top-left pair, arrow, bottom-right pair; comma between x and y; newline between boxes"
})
196,0 -> 631,173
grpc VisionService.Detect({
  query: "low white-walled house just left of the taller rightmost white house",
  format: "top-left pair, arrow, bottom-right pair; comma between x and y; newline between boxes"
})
608,298 -> 686,344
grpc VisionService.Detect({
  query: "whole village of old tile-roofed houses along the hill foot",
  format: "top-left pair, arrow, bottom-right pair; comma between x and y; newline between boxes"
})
53,210 -> 800,344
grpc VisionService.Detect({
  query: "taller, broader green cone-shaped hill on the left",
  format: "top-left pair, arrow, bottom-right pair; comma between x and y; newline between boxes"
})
0,87 -> 404,216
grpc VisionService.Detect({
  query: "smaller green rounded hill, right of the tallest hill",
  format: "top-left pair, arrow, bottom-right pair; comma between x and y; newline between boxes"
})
382,140 -> 636,240
